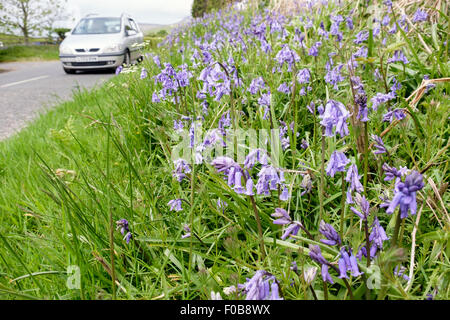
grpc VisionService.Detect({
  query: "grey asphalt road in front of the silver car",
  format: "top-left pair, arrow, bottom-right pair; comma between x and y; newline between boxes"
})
0,61 -> 114,140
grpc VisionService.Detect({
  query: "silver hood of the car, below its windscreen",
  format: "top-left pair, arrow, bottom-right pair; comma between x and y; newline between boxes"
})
61,33 -> 122,49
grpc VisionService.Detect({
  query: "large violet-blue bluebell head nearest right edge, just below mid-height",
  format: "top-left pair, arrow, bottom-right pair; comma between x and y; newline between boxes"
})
386,171 -> 425,219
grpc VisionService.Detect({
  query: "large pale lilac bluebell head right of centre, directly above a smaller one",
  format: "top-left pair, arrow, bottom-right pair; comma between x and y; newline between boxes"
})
319,100 -> 350,137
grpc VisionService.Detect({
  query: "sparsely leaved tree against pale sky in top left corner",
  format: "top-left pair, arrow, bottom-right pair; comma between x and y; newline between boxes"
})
0,0 -> 71,44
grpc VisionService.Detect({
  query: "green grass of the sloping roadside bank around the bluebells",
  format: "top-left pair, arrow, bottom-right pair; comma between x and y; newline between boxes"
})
0,0 -> 450,299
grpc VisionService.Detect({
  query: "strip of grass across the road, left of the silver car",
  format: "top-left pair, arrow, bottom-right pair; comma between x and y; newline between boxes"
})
0,45 -> 59,62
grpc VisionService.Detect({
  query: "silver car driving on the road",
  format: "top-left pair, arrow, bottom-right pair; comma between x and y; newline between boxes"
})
59,14 -> 144,74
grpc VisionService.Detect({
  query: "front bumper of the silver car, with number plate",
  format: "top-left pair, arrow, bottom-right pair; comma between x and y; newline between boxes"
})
59,52 -> 124,70
